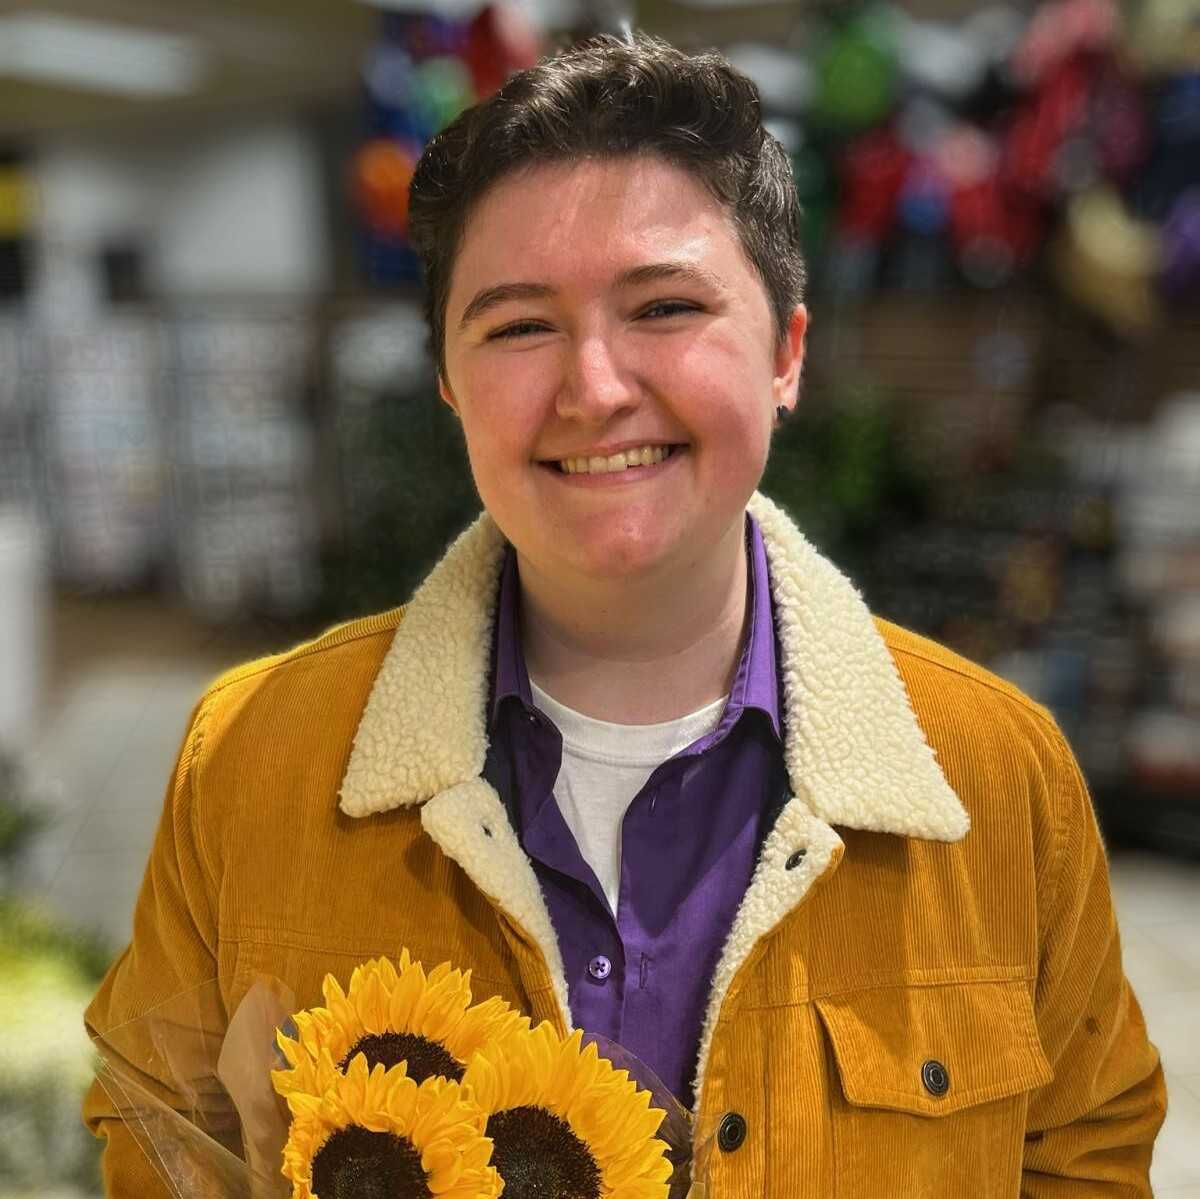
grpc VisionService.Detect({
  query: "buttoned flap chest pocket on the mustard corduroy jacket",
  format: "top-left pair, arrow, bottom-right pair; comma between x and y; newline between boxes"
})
815,982 -> 1052,1199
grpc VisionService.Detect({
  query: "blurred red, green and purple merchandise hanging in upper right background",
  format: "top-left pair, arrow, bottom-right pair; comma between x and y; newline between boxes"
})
733,0 -> 1200,328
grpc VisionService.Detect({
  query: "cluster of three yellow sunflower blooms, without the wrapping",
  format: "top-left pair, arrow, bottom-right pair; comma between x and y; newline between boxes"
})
272,952 -> 672,1199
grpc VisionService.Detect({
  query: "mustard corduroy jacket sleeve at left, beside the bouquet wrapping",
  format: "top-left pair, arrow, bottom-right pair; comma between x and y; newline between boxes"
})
83,701 -> 224,1199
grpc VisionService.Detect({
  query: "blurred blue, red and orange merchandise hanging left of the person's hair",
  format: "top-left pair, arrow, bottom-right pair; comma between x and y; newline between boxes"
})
350,2 -> 540,287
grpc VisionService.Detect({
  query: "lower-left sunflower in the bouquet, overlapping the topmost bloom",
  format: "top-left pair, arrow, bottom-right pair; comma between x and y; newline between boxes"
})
282,1054 -> 502,1199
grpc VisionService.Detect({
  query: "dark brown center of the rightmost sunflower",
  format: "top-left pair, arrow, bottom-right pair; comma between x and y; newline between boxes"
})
487,1107 -> 600,1199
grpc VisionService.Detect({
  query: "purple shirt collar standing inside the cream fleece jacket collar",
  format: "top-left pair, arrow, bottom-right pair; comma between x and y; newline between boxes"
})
490,512 -> 782,739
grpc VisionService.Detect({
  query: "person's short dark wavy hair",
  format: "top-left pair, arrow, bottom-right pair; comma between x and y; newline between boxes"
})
408,34 -> 804,376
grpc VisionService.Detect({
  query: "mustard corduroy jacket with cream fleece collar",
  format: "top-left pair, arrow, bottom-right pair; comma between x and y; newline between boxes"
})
85,496 -> 1165,1199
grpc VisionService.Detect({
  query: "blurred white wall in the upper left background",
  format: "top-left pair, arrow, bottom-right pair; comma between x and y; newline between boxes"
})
34,119 -> 330,304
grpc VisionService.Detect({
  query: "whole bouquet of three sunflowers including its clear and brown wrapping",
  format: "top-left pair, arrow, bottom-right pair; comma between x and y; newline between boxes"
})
98,951 -> 700,1199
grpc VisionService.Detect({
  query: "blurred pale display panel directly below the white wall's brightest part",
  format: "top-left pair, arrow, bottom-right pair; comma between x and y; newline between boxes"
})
167,304 -> 319,621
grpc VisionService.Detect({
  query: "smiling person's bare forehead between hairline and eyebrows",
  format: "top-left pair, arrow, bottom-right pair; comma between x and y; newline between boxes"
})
449,155 -> 749,302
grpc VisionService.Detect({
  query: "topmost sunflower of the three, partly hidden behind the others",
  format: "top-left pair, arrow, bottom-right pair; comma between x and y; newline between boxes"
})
272,949 -> 529,1096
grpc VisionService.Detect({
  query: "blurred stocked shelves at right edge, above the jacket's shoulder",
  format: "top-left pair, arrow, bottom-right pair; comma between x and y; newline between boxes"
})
964,394 -> 1200,852
